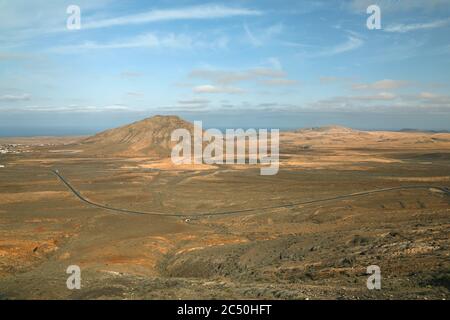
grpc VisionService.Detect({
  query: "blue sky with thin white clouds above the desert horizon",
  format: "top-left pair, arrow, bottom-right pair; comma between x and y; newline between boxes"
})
0,0 -> 450,136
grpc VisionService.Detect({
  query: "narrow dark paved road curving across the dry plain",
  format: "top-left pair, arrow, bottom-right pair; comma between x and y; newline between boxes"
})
51,170 -> 450,218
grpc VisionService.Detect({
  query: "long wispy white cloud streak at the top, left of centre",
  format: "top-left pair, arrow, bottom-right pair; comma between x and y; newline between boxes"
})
83,4 -> 263,29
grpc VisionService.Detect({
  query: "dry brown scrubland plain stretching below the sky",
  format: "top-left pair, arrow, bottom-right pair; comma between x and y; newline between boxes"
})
0,117 -> 450,299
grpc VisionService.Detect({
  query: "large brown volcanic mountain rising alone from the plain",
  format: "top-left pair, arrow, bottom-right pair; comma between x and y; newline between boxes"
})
80,115 -> 194,157
